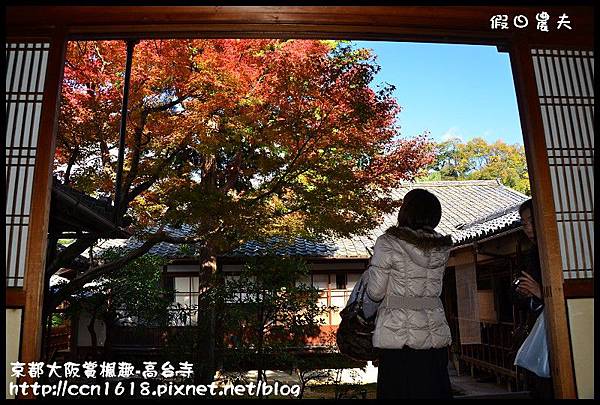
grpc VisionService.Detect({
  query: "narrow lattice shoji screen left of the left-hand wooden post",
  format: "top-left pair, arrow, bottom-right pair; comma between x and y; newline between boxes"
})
5,43 -> 50,287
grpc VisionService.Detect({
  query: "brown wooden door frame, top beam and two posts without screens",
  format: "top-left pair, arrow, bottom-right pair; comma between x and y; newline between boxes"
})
6,6 -> 594,398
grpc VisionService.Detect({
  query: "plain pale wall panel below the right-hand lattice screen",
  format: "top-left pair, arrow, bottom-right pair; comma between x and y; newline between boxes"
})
567,298 -> 594,399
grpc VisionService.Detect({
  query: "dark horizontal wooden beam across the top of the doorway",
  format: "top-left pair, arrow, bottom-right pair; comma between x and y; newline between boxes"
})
6,6 -> 593,46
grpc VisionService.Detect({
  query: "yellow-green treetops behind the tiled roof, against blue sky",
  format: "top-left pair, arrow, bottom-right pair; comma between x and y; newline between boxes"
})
424,138 -> 531,195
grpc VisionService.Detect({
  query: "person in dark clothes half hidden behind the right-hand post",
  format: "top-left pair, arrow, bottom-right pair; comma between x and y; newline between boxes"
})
516,199 -> 554,399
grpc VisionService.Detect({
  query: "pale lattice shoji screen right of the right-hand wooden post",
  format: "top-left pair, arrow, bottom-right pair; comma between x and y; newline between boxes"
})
531,49 -> 594,279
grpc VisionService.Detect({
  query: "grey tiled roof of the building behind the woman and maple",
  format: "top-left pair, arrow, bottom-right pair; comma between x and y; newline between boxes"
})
91,180 -> 529,258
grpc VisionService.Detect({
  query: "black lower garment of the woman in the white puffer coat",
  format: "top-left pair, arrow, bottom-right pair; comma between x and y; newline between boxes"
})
377,346 -> 452,399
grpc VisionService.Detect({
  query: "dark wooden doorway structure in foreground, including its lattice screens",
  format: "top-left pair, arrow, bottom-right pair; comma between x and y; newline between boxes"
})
5,5 -> 595,398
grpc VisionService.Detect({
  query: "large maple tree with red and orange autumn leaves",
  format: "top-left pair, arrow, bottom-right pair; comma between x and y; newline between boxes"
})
47,39 -> 433,378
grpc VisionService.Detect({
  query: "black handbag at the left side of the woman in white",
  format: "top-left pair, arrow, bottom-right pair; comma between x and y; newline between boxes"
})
336,279 -> 377,361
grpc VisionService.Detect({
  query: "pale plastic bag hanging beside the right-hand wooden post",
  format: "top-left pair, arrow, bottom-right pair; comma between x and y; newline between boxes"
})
515,312 -> 550,378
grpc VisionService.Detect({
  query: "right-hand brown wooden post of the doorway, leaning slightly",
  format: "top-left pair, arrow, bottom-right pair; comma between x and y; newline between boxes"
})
510,43 -> 577,398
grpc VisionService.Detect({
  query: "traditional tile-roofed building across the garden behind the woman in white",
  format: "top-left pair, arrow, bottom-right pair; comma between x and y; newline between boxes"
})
78,180 -> 528,389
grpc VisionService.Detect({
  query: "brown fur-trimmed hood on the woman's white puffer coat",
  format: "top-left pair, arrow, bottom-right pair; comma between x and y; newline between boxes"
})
385,226 -> 452,268
